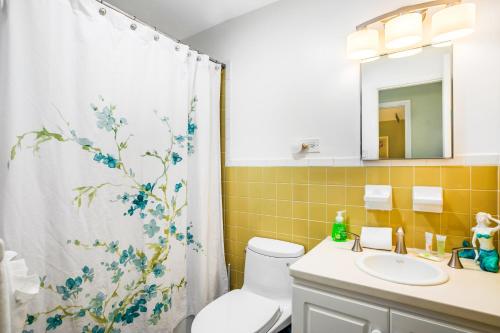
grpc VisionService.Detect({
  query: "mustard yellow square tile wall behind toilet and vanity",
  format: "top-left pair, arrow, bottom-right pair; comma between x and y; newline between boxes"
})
221,73 -> 500,288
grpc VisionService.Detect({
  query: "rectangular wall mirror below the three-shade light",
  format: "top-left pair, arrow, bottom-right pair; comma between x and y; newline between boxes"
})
361,46 -> 453,160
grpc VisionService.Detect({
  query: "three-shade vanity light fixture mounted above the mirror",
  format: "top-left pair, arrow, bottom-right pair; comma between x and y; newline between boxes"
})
347,0 -> 476,60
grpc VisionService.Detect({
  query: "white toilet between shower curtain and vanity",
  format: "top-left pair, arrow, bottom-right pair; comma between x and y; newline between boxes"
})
191,237 -> 304,333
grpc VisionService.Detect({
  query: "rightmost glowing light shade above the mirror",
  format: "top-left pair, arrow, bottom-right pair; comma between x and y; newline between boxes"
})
432,3 -> 476,43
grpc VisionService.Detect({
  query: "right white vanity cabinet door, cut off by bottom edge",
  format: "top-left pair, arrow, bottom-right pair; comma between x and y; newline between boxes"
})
391,310 -> 477,333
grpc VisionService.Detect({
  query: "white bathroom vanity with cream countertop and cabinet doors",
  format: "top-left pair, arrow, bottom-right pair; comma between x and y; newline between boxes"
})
290,238 -> 500,333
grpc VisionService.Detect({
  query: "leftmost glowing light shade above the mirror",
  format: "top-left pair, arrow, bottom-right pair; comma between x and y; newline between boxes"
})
347,29 -> 379,59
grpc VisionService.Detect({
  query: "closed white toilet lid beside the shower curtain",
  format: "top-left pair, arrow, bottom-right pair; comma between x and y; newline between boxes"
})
191,290 -> 281,333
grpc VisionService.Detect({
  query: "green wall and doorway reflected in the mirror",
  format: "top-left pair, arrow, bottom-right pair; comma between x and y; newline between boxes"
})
378,80 -> 443,159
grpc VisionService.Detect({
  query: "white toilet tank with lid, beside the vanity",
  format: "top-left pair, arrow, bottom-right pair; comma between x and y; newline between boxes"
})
242,237 -> 304,301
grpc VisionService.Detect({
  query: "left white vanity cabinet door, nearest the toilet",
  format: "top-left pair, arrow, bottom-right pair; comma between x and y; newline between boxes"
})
292,285 -> 389,333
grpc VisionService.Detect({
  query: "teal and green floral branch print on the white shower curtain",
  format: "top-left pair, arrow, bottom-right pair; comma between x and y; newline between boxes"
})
11,96 -> 201,333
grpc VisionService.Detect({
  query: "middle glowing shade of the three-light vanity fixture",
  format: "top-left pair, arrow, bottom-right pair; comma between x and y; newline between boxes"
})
385,13 -> 423,50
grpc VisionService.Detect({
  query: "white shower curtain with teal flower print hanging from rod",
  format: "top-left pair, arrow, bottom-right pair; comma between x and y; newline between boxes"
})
0,0 -> 227,333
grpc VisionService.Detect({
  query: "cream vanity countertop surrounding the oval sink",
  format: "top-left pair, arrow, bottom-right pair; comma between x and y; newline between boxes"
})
290,238 -> 500,327
